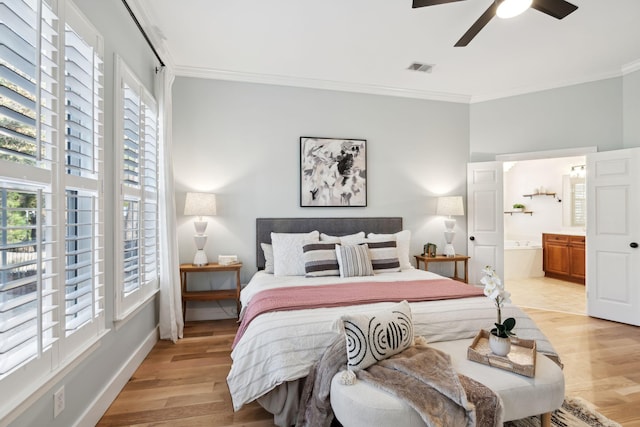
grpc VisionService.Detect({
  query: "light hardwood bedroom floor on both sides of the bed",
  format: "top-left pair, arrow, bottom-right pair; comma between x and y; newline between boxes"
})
98,280 -> 640,427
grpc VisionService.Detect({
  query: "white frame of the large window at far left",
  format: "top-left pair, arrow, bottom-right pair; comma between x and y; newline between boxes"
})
0,0 -> 108,419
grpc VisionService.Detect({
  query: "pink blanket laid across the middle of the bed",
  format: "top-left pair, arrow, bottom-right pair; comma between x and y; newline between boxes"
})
232,279 -> 484,348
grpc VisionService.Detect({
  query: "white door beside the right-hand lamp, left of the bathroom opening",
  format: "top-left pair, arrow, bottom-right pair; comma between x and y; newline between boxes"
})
467,162 -> 504,284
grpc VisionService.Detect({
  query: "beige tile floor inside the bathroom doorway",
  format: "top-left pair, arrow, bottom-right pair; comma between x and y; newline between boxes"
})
505,277 -> 587,315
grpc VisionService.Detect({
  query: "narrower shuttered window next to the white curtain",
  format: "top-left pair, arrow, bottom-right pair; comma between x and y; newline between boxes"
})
116,58 -> 159,319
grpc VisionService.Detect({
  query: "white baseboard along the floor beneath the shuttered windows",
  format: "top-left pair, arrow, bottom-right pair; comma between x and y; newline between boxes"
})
75,327 -> 160,427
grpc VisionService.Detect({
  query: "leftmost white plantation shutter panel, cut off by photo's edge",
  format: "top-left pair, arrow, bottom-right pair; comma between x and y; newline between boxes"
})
0,1 -> 58,379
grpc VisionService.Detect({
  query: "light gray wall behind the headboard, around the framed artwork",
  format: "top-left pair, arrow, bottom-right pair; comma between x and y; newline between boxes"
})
173,77 -> 469,318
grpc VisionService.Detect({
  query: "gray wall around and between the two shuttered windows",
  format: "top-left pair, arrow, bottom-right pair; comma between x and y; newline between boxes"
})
11,0 -> 158,427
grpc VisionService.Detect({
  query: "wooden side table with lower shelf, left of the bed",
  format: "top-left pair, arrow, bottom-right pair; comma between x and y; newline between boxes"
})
180,263 -> 242,320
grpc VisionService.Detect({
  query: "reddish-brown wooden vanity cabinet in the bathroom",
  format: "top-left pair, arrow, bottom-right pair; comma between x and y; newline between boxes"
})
542,233 -> 586,285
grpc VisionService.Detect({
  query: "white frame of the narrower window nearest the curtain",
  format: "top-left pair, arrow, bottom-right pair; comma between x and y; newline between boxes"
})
114,55 -> 160,321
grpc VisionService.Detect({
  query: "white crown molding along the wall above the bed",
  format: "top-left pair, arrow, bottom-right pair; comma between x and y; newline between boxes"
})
174,66 -> 471,104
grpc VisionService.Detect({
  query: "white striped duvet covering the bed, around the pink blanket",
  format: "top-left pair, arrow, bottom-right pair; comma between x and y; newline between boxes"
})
227,269 -> 554,410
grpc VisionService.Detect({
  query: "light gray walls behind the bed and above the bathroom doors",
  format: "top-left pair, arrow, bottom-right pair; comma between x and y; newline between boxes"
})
173,72 -> 640,319
